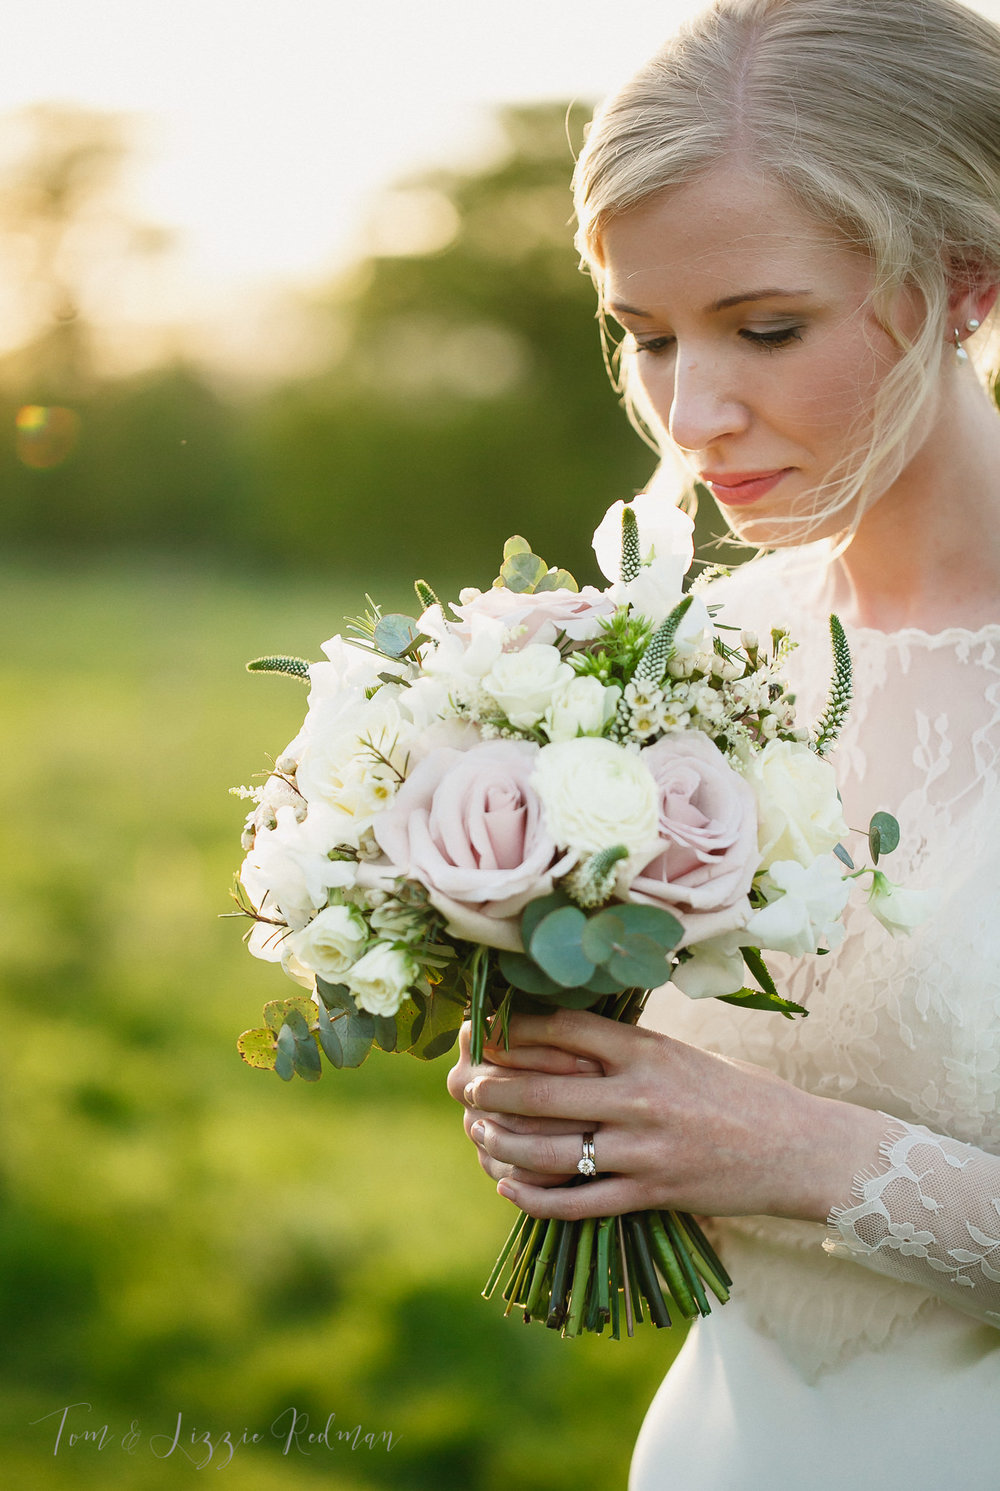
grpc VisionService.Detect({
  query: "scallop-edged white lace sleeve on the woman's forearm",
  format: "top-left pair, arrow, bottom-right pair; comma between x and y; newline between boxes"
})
823,1114 -> 1000,1327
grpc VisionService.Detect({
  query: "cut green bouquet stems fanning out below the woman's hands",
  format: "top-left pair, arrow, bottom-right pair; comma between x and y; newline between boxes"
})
483,990 -> 733,1340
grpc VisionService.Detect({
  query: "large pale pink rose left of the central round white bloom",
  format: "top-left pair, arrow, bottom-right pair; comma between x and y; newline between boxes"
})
373,741 -> 575,951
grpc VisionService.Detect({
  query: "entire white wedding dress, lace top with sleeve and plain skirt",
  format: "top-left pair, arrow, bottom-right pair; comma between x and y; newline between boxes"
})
629,553 -> 1000,1491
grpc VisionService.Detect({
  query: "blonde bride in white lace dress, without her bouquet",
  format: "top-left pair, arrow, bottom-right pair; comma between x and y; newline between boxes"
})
449,0 -> 1000,1491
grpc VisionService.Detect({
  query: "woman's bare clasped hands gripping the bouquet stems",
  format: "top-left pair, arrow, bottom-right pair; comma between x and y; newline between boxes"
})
449,1009 -> 884,1221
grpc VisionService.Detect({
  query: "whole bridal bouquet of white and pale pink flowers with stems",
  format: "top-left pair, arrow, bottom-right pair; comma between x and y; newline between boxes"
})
234,497 -> 915,1337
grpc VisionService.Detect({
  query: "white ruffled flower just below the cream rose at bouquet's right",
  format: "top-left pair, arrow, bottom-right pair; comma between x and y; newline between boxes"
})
745,854 -> 851,957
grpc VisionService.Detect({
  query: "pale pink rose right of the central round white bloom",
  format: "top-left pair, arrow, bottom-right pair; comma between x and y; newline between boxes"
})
623,732 -> 760,947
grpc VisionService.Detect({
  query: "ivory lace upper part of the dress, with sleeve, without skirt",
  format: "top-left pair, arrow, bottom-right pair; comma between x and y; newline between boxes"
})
640,555 -> 1000,1373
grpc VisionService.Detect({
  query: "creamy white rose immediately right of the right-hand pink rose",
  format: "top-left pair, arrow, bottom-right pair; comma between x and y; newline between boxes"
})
744,741 -> 848,869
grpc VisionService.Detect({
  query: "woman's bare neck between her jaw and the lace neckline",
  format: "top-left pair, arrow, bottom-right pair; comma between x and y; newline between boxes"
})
830,368 -> 1000,632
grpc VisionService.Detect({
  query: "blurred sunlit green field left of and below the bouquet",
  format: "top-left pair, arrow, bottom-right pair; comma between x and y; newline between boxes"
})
0,559 -> 680,1491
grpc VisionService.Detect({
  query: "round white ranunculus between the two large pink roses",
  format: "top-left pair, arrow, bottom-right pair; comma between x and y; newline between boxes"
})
532,735 -> 660,854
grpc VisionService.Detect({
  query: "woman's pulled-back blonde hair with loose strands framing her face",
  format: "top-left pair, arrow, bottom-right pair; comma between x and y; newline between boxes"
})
574,0 -> 1000,538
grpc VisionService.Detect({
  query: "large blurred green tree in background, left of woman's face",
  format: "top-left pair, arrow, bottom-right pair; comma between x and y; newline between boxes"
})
244,104 -> 664,584
